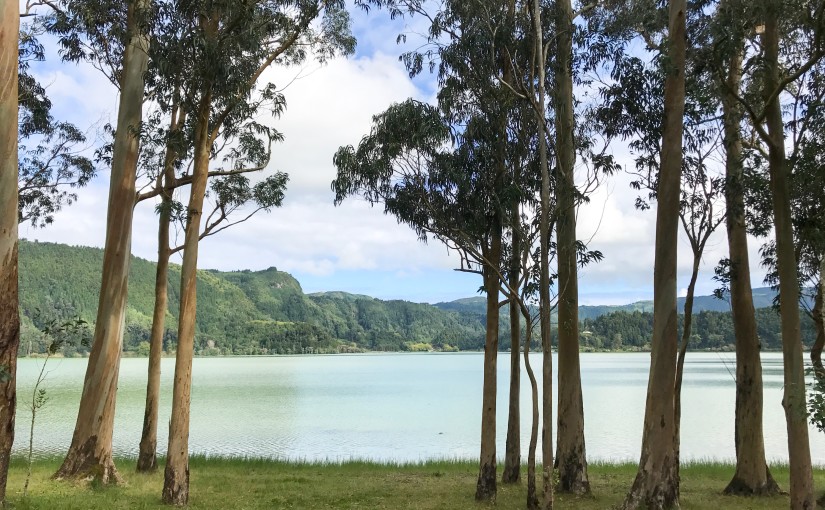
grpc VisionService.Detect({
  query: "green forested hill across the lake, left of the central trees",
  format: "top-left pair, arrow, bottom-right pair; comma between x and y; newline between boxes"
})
20,241 -> 484,354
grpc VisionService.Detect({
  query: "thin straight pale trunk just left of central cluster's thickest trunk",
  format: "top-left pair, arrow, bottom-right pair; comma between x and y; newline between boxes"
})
533,0 -> 553,504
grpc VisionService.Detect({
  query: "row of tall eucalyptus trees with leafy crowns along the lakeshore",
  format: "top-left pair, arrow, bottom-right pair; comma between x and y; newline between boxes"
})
0,0 -> 825,509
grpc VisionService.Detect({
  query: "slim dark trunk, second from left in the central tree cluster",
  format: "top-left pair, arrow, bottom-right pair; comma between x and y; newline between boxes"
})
501,213 -> 529,483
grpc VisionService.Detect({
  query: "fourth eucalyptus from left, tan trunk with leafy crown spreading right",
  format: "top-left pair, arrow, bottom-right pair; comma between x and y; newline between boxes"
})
163,0 -> 355,505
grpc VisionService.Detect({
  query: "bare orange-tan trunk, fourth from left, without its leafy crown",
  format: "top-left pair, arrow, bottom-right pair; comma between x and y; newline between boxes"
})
163,90 -> 212,506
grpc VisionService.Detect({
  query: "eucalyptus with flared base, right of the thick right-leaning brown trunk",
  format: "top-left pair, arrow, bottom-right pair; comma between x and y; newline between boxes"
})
704,0 -> 779,495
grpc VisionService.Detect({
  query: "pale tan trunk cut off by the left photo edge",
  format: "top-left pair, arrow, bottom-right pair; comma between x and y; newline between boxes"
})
0,0 -> 20,506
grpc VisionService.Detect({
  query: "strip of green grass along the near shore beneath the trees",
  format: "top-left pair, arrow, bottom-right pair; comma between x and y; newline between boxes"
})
3,458 -> 825,510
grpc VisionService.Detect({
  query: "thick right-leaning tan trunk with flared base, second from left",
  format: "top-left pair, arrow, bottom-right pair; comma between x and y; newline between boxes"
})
55,0 -> 149,483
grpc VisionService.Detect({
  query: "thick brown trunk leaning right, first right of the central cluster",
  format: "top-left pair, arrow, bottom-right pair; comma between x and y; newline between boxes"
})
622,0 -> 686,510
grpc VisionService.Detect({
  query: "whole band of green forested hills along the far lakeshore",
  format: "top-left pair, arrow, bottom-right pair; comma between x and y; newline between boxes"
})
20,241 -> 816,356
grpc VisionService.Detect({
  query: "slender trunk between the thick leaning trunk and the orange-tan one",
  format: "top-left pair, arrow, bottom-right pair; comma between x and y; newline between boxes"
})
137,103 -> 184,473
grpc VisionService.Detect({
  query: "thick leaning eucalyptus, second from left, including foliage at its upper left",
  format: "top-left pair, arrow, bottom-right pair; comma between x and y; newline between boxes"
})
51,0 -> 151,483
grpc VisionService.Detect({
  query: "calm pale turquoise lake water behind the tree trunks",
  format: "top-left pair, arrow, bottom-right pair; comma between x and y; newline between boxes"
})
15,353 -> 825,465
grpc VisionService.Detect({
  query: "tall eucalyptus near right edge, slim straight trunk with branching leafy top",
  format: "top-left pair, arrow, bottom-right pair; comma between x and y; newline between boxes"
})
717,0 -> 825,508
